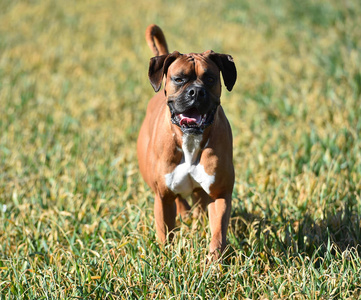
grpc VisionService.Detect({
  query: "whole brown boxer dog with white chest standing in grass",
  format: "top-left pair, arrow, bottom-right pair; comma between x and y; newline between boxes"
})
137,25 -> 237,257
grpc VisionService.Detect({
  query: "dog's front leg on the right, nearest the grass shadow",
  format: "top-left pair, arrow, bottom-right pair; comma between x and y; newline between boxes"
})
208,195 -> 232,259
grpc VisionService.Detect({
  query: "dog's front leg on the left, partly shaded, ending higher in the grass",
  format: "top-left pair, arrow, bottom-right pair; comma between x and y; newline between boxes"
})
154,194 -> 177,243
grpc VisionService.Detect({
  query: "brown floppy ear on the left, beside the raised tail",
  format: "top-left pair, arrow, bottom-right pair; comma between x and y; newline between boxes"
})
148,51 -> 181,92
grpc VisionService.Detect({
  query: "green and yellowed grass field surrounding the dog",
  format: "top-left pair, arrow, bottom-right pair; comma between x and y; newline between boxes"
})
0,0 -> 361,299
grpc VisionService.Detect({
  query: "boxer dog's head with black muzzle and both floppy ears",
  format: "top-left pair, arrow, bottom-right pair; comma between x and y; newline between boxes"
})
148,50 -> 237,134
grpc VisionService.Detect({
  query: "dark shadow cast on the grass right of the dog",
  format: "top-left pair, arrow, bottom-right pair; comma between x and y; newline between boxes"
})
229,207 -> 361,261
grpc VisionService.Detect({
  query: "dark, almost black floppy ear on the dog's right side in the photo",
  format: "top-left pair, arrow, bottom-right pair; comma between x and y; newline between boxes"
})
205,50 -> 237,91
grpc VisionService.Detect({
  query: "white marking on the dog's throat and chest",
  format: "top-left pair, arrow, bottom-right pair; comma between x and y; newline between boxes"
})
165,134 -> 215,197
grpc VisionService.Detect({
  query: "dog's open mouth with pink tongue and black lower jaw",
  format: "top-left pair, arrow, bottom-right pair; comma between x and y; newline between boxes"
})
169,103 -> 217,134
